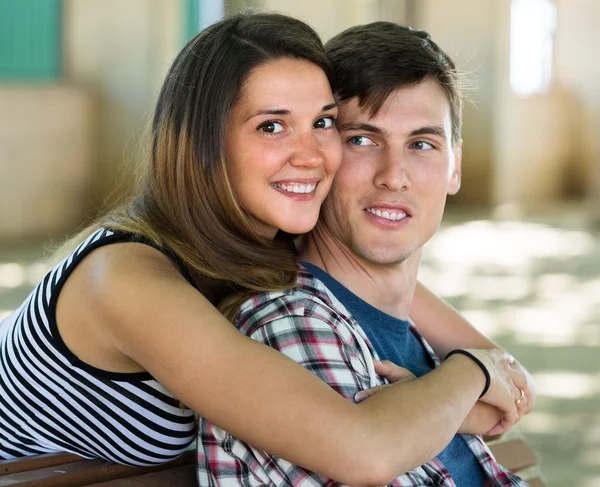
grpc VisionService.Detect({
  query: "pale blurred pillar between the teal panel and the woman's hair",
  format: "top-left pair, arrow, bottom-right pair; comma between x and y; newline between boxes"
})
64,0 -> 184,205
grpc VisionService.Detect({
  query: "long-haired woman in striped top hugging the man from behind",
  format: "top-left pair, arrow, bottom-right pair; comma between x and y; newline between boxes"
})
0,9 -> 536,483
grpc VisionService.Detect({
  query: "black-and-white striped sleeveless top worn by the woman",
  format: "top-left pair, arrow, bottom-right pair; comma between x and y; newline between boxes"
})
0,229 -> 195,465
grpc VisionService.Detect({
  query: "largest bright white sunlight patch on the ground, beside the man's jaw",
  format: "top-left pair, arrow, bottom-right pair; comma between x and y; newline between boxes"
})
426,221 -> 595,272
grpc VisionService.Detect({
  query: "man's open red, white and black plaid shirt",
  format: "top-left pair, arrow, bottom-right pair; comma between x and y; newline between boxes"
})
198,267 -> 527,487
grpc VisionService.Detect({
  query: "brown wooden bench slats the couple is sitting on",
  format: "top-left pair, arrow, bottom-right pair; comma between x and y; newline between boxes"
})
0,437 -> 546,487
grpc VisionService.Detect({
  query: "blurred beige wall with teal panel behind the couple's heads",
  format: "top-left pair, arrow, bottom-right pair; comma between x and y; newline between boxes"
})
0,0 -> 600,239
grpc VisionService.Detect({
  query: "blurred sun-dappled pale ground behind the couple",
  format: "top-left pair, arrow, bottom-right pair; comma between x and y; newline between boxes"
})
0,209 -> 600,487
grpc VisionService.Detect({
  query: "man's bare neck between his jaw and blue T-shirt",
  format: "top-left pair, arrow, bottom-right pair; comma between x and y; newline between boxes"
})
299,225 -> 421,320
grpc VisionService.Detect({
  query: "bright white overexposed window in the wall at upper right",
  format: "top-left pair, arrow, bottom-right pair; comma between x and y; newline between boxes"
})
510,0 -> 556,96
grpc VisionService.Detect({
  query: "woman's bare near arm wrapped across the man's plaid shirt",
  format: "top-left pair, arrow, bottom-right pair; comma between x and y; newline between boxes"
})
62,244 -> 516,485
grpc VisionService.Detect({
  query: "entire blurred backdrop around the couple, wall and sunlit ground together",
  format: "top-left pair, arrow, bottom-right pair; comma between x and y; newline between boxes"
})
0,0 -> 600,487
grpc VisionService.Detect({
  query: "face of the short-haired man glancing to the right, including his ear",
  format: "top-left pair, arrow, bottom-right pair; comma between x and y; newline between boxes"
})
321,81 -> 462,266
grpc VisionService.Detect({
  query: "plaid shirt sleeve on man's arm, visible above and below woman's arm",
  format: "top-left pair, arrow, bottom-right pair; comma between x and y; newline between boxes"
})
198,302 -> 376,487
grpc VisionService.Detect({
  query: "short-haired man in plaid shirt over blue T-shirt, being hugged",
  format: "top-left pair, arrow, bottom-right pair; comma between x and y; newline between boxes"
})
199,22 -> 526,487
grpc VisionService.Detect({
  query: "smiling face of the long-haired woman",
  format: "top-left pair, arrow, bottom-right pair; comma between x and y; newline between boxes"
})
226,58 -> 342,237
